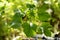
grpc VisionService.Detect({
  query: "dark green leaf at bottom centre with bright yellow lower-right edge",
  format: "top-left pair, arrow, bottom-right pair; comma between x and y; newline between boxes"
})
23,23 -> 36,37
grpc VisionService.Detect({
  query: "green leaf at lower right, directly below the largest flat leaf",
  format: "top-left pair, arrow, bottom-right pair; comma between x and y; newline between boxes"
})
41,22 -> 53,36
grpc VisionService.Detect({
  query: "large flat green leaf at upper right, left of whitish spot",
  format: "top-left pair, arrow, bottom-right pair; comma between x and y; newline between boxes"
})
38,4 -> 50,21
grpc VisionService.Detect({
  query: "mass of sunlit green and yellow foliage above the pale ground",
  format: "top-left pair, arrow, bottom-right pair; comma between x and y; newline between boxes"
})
0,0 -> 60,37
